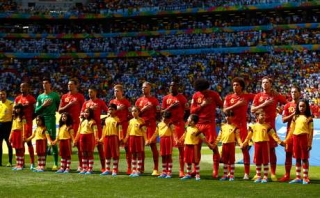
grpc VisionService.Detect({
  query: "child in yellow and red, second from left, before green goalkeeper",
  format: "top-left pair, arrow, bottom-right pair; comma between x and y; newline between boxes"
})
26,115 -> 52,172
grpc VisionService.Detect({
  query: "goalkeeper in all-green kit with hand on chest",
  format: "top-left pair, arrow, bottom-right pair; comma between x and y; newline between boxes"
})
35,78 -> 60,171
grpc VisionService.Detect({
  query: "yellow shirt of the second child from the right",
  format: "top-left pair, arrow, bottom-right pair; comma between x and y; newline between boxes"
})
246,123 -> 281,143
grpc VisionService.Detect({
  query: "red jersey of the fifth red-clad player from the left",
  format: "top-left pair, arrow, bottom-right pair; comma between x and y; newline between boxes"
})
135,96 -> 160,122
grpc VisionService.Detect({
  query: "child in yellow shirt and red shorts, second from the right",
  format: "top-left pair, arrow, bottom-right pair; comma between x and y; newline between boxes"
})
243,109 -> 284,183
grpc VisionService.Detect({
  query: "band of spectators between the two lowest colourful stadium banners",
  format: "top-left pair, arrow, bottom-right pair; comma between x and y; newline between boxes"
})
0,29 -> 320,53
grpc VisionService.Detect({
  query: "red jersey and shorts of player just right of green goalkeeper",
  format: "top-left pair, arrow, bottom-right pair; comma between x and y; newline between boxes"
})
60,93 -> 84,128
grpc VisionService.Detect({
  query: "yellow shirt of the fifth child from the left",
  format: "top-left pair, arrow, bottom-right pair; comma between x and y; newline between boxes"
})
102,117 -> 123,138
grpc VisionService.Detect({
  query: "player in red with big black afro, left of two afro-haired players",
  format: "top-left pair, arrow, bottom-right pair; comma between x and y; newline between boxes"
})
190,79 -> 223,178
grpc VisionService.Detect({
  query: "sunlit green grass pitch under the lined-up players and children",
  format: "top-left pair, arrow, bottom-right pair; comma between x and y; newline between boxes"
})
0,148 -> 320,198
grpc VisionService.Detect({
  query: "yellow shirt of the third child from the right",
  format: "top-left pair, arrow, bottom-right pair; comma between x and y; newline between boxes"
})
215,124 -> 241,145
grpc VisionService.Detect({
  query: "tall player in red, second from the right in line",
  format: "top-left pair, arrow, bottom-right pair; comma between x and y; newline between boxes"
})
251,76 -> 287,181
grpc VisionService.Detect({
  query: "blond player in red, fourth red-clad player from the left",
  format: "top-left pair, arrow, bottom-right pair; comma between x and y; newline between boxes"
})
109,85 -> 131,175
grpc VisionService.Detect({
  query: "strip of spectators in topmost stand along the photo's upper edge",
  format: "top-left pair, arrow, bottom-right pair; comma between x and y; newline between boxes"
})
0,0 -> 310,14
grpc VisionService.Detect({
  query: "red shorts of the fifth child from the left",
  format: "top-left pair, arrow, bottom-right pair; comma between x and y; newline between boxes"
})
103,135 -> 120,159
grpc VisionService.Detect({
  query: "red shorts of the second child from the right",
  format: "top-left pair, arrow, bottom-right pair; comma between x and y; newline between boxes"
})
254,141 -> 270,165
